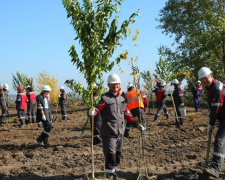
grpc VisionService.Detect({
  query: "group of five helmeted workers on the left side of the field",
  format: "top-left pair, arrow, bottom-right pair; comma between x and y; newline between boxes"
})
0,84 -> 67,146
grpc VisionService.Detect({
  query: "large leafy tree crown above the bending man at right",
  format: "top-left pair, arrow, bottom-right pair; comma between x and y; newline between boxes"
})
158,0 -> 225,79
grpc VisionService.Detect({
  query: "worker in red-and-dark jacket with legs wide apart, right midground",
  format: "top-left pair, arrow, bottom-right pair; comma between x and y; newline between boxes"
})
154,81 -> 170,121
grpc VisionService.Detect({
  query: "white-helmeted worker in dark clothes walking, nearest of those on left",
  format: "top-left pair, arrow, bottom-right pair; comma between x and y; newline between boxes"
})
36,85 -> 52,146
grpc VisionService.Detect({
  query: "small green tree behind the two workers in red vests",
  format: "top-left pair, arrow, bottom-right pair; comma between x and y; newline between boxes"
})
12,72 -> 34,90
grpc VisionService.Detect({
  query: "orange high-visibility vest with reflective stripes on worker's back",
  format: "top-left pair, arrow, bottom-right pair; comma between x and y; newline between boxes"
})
126,89 -> 144,110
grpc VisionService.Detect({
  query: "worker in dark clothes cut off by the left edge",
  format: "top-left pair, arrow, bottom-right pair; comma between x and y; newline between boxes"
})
0,84 -> 9,124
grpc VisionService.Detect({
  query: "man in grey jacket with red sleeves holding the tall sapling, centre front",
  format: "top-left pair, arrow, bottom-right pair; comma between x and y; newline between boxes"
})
90,73 -> 145,180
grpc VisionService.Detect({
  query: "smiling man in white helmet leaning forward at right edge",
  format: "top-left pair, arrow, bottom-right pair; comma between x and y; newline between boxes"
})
198,67 -> 225,178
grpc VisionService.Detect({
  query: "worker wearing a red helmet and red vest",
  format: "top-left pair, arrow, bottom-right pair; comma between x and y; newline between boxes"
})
15,86 -> 27,128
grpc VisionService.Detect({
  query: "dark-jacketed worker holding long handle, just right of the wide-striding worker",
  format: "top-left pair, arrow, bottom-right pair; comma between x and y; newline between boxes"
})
172,79 -> 184,125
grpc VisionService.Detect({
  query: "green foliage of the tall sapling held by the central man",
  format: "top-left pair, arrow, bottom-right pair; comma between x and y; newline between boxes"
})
62,0 -> 138,108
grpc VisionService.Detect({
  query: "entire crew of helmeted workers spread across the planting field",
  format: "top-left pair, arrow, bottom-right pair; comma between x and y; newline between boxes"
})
0,67 -> 225,180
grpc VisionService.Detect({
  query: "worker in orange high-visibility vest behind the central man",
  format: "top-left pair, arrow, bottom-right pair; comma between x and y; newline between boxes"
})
124,84 -> 147,137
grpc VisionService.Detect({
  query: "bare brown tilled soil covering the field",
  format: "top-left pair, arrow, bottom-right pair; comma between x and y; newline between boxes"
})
0,106 -> 225,180
